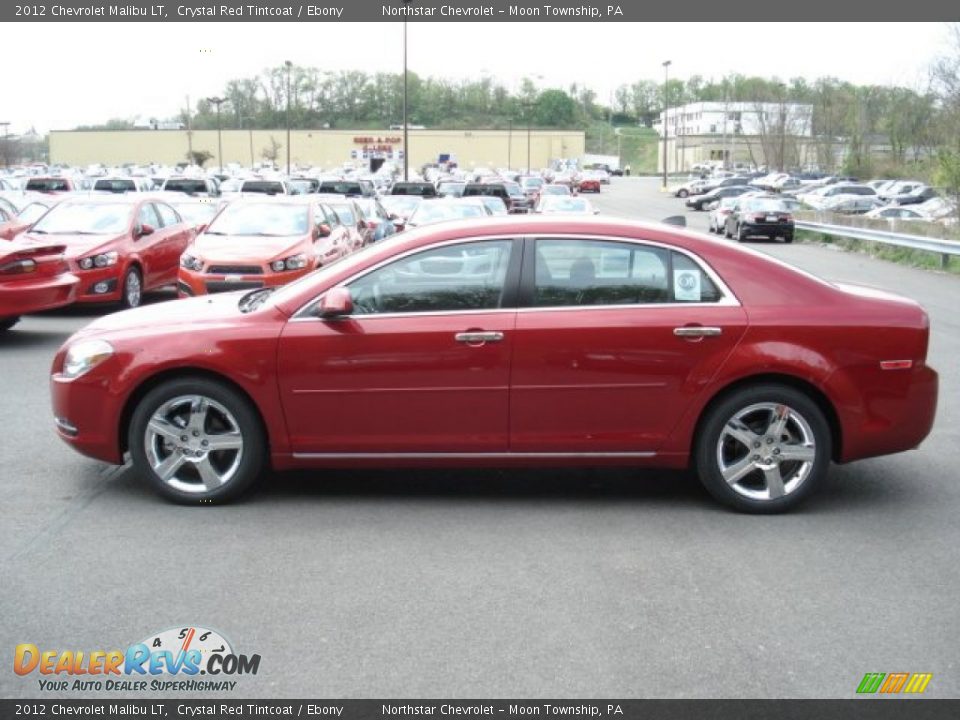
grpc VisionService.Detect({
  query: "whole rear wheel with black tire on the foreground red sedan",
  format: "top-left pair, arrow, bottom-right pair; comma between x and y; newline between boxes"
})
694,383 -> 832,513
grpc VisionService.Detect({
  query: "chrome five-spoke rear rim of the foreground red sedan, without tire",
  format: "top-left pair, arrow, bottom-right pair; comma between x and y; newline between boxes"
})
716,402 -> 817,500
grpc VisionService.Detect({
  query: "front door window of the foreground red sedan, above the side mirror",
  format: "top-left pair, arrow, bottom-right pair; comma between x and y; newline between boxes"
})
348,240 -> 513,315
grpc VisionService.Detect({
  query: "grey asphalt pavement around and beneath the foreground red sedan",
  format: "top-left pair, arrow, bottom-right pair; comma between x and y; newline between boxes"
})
0,178 -> 960,698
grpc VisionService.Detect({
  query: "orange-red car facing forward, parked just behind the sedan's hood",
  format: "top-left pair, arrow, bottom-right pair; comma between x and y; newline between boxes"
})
177,195 -> 352,297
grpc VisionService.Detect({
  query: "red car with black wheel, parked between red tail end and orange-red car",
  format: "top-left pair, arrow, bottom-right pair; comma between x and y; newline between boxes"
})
20,195 -> 194,308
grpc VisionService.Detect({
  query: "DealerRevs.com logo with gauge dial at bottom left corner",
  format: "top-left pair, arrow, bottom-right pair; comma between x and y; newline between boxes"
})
13,626 -> 260,692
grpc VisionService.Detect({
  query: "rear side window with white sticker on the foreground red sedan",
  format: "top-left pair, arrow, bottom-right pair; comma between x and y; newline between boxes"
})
533,240 -> 721,307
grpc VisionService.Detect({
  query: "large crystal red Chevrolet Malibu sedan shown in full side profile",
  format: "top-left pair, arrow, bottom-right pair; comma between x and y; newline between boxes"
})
51,217 -> 938,512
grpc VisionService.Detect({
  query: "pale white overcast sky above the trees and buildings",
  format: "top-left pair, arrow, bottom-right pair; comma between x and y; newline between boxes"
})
0,22 -> 947,134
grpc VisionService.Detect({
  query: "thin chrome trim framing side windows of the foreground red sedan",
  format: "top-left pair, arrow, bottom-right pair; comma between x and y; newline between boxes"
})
290,233 -> 741,322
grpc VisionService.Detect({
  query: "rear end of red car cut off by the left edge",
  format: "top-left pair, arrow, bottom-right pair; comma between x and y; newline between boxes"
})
0,239 -> 80,332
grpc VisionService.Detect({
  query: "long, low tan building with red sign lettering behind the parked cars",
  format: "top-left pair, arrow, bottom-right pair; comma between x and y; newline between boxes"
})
50,128 -> 586,169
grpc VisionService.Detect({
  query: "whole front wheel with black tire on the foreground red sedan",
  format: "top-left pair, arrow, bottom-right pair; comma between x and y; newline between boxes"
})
129,378 -> 265,505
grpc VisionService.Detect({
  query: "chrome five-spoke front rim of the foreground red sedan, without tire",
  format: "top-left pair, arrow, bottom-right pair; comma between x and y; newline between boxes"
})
143,395 -> 243,493
